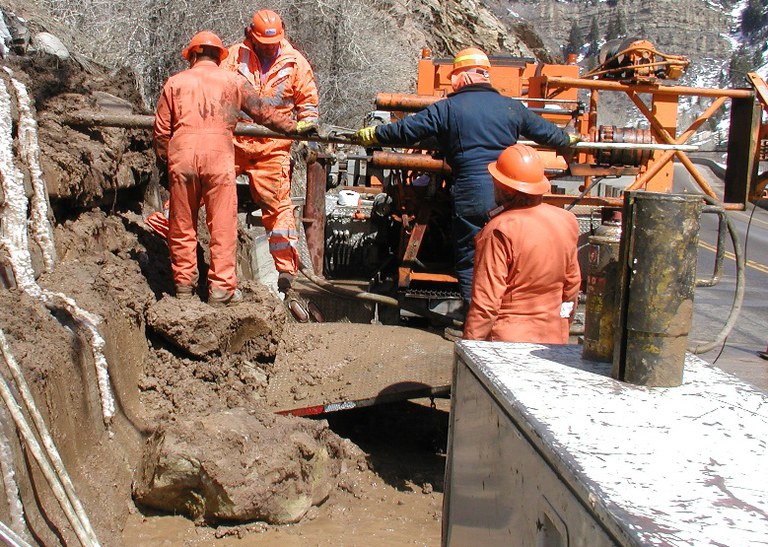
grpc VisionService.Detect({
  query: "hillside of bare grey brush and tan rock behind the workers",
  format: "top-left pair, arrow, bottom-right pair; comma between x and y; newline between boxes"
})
0,0 -> 529,126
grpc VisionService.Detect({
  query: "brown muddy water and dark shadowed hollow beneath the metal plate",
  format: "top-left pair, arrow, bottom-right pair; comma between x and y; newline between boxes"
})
122,400 -> 448,546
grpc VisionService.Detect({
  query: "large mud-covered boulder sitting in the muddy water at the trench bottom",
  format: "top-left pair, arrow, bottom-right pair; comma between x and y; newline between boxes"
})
133,409 -> 344,524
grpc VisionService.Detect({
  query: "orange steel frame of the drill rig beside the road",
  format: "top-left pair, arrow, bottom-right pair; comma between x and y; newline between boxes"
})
366,50 -> 768,300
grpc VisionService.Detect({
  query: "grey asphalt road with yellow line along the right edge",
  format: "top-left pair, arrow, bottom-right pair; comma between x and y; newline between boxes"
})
675,165 -> 768,391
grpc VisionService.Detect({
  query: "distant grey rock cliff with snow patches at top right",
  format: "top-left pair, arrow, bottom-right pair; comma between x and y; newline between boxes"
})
486,0 -> 746,136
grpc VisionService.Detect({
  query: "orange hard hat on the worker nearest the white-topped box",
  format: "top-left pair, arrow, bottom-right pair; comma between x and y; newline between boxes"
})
488,144 -> 550,196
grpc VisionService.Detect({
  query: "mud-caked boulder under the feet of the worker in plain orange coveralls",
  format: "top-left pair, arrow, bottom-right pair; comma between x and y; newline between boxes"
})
146,283 -> 286,358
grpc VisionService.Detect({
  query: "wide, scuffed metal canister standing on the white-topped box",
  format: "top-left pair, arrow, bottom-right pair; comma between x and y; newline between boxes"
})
612,191 -> 704,387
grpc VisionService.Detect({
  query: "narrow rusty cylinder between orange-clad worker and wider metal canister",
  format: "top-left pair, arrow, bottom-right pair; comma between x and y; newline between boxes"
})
582,207 -> 621,362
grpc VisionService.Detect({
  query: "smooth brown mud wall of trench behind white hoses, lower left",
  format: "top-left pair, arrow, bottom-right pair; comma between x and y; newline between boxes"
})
0,272 -> 147,545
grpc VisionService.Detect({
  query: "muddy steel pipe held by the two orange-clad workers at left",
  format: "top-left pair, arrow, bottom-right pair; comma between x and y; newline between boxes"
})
64,112 -> 354,144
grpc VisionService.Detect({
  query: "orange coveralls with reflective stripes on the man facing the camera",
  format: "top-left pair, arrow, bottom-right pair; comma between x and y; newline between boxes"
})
222,40 -> 318,275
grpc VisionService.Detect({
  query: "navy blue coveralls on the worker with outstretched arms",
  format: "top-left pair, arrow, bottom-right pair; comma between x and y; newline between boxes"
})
376,83 -> 568,304
